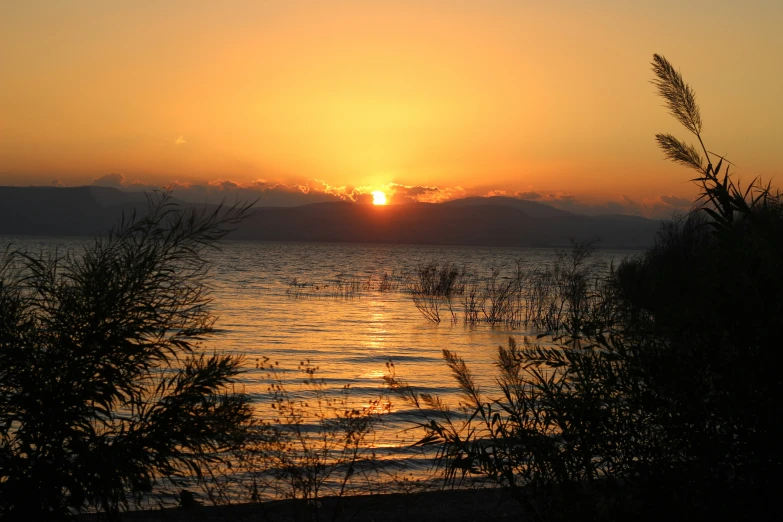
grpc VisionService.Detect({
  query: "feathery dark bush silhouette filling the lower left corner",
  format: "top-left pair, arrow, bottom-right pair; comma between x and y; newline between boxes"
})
0,194 -> 250,519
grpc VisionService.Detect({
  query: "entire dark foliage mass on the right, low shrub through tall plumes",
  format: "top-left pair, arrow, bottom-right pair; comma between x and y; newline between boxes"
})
390,55 -> 783,520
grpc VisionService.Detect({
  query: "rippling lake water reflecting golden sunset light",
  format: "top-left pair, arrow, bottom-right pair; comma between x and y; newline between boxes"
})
0,238 -> 639,498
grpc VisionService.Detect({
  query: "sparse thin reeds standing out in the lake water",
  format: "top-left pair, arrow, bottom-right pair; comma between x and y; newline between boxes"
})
286,248 -> 607,333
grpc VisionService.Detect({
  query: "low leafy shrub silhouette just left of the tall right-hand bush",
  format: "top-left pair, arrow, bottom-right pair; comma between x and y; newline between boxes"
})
387,258 -> 640,519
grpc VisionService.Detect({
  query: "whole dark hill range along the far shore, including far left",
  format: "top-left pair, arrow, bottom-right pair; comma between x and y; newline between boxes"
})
0,187 -> 659,248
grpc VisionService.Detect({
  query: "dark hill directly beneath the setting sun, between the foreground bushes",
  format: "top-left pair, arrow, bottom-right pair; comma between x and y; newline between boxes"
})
231,202 -> 659,248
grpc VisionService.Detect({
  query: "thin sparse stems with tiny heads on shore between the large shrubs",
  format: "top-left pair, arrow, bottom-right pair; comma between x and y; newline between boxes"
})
234,358 -> 391,520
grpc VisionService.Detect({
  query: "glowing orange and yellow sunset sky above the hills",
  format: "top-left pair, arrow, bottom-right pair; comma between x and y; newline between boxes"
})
0,0 -> 783,214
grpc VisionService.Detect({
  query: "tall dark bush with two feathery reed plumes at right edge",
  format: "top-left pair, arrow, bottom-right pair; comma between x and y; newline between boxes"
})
615,51 -> 783,516
